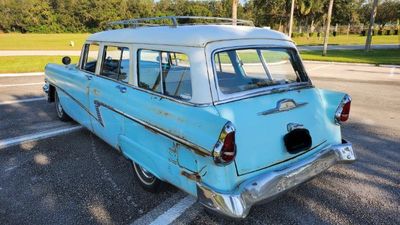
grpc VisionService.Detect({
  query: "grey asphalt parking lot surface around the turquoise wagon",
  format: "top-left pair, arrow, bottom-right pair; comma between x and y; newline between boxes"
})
0,62 -> 400,225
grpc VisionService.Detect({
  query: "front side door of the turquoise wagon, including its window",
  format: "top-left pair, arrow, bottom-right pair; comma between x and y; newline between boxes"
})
58,43 -> 98,130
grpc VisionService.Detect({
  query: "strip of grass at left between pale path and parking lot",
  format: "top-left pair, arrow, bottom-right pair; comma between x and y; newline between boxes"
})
0,56 -> 79,73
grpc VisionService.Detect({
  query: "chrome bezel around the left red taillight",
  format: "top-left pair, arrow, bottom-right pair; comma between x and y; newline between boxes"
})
212,122 -> 236,166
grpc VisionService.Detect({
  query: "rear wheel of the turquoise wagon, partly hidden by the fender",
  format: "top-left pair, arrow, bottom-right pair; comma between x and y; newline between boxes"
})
132,161 -> 163,193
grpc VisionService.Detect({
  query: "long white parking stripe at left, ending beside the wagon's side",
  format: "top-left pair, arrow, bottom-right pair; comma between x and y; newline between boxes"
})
0,125 -> 83,149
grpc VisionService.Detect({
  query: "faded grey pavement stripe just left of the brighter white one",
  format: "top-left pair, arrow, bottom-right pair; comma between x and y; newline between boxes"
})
130,191 -> 186,225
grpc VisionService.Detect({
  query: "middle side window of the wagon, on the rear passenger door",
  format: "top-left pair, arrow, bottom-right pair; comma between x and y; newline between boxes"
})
100,46 -> 130,83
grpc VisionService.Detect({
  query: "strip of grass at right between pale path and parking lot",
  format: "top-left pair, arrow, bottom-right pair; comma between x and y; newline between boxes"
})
300,49 -> 400,65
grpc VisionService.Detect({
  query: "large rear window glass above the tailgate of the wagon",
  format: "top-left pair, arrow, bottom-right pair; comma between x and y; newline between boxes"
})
214,48 -> 308,94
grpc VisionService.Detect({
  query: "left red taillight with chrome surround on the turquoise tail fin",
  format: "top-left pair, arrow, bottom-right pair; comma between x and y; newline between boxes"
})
213,122 -> 236,165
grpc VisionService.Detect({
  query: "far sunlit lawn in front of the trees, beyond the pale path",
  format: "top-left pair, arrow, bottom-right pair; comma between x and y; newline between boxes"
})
0,33 -> 400,50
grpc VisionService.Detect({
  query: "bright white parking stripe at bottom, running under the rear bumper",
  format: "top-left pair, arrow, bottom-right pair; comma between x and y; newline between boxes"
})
150,195 -> 196,225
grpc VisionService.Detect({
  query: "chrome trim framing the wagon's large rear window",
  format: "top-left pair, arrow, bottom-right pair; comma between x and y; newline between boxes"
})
211,45 -> 314,105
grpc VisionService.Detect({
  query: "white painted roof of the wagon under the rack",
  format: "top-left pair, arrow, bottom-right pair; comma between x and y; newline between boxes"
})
88,25 -> 291,47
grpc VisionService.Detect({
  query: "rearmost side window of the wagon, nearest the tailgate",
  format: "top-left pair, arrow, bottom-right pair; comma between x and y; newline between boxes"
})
138,50 -> 192,101
